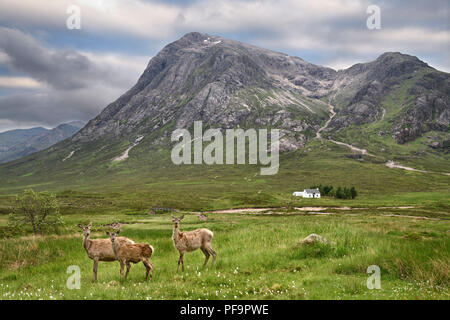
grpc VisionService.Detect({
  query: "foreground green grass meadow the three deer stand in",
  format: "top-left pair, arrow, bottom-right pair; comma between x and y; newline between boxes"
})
0,205 -> 450,299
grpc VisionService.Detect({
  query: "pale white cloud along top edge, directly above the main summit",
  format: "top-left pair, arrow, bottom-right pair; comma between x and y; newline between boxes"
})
179,0 -> 367,32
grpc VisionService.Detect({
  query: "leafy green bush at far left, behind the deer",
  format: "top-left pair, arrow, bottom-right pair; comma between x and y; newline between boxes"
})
8,190 -> 64,235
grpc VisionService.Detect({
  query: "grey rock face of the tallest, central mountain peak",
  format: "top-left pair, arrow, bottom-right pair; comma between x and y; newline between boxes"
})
72,33 -> 336,149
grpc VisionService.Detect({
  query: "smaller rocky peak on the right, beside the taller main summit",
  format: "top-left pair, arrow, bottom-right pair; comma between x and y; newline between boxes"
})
330,52 -> 450,144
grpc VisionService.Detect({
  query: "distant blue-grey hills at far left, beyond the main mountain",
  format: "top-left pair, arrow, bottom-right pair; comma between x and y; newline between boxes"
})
0,121 -> 84,163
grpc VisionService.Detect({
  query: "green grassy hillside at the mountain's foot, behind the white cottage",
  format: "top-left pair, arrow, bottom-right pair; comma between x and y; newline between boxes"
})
0,134 -> 450,210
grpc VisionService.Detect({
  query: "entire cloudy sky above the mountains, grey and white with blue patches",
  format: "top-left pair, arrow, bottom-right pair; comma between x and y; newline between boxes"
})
0,0 -> 450,132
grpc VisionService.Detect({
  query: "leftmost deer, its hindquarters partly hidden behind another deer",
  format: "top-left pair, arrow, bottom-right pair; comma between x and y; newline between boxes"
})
78,222 -> 134,281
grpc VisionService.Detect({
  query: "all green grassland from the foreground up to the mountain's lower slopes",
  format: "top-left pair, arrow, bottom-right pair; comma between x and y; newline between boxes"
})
0,128 -> 450,299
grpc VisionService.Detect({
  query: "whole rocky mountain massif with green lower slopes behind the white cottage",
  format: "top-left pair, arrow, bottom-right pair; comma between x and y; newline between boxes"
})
0,32 -> 450,195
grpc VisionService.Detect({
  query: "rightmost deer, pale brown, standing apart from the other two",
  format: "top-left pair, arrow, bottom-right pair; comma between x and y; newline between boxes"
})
172,215 -> 217,272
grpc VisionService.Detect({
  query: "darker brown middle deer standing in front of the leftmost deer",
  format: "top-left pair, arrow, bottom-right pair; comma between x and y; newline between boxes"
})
106,230 -> 155,281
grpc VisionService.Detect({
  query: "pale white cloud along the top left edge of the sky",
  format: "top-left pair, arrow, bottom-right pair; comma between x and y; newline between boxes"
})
0,0 -> 181,39
